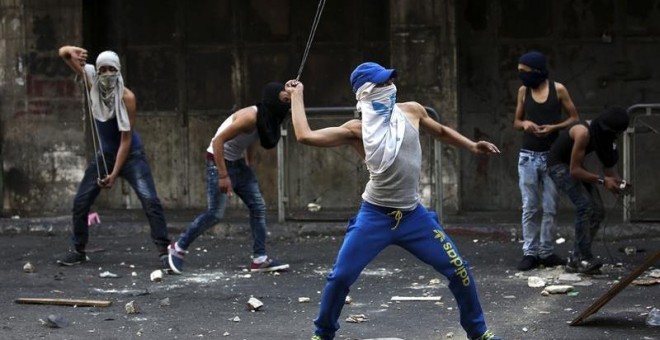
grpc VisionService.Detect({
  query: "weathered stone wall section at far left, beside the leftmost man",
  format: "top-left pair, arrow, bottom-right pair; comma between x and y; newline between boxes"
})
0,0 -> 85,212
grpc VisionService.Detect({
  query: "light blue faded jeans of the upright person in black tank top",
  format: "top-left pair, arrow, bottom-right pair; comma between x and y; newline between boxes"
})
518,150 -> 559,258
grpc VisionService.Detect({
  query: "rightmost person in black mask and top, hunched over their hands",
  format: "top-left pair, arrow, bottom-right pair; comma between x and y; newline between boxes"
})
548,108 -> 629,274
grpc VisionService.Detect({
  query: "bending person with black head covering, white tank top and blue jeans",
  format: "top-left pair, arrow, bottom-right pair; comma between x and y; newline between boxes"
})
168,82 -> 291,274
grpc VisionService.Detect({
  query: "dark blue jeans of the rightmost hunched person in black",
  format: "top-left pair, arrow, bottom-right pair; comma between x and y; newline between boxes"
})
549,164 -> 605,259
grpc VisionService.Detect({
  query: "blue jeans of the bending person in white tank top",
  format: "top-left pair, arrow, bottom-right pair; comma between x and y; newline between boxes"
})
177,158 -> 266,257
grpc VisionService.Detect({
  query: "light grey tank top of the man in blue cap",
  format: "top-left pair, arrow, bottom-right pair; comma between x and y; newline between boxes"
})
362,114 -> 422,210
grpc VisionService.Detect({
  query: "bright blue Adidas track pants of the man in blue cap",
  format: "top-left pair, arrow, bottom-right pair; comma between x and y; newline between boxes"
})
314,202 -> 486,339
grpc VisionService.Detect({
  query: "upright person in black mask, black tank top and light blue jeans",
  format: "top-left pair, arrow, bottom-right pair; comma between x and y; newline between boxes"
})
513,51 -> 578,271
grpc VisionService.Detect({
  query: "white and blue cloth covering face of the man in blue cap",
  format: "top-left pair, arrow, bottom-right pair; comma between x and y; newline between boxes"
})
355,82 -> 405,174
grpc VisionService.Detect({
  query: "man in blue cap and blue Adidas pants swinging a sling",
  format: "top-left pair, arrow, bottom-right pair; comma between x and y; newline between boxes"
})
285,63 -> 500,340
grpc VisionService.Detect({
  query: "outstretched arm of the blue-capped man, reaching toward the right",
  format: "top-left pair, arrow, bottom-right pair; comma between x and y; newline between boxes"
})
408,102 -> 500,154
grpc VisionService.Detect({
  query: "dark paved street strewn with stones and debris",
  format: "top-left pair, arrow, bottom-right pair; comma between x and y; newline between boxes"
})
0,211 -> 660,340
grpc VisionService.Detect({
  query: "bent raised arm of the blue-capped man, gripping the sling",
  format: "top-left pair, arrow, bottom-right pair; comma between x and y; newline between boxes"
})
285,80 -> 364,157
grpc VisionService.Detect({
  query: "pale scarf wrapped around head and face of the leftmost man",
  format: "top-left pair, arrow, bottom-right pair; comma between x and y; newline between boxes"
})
90,51 -> 131,131
